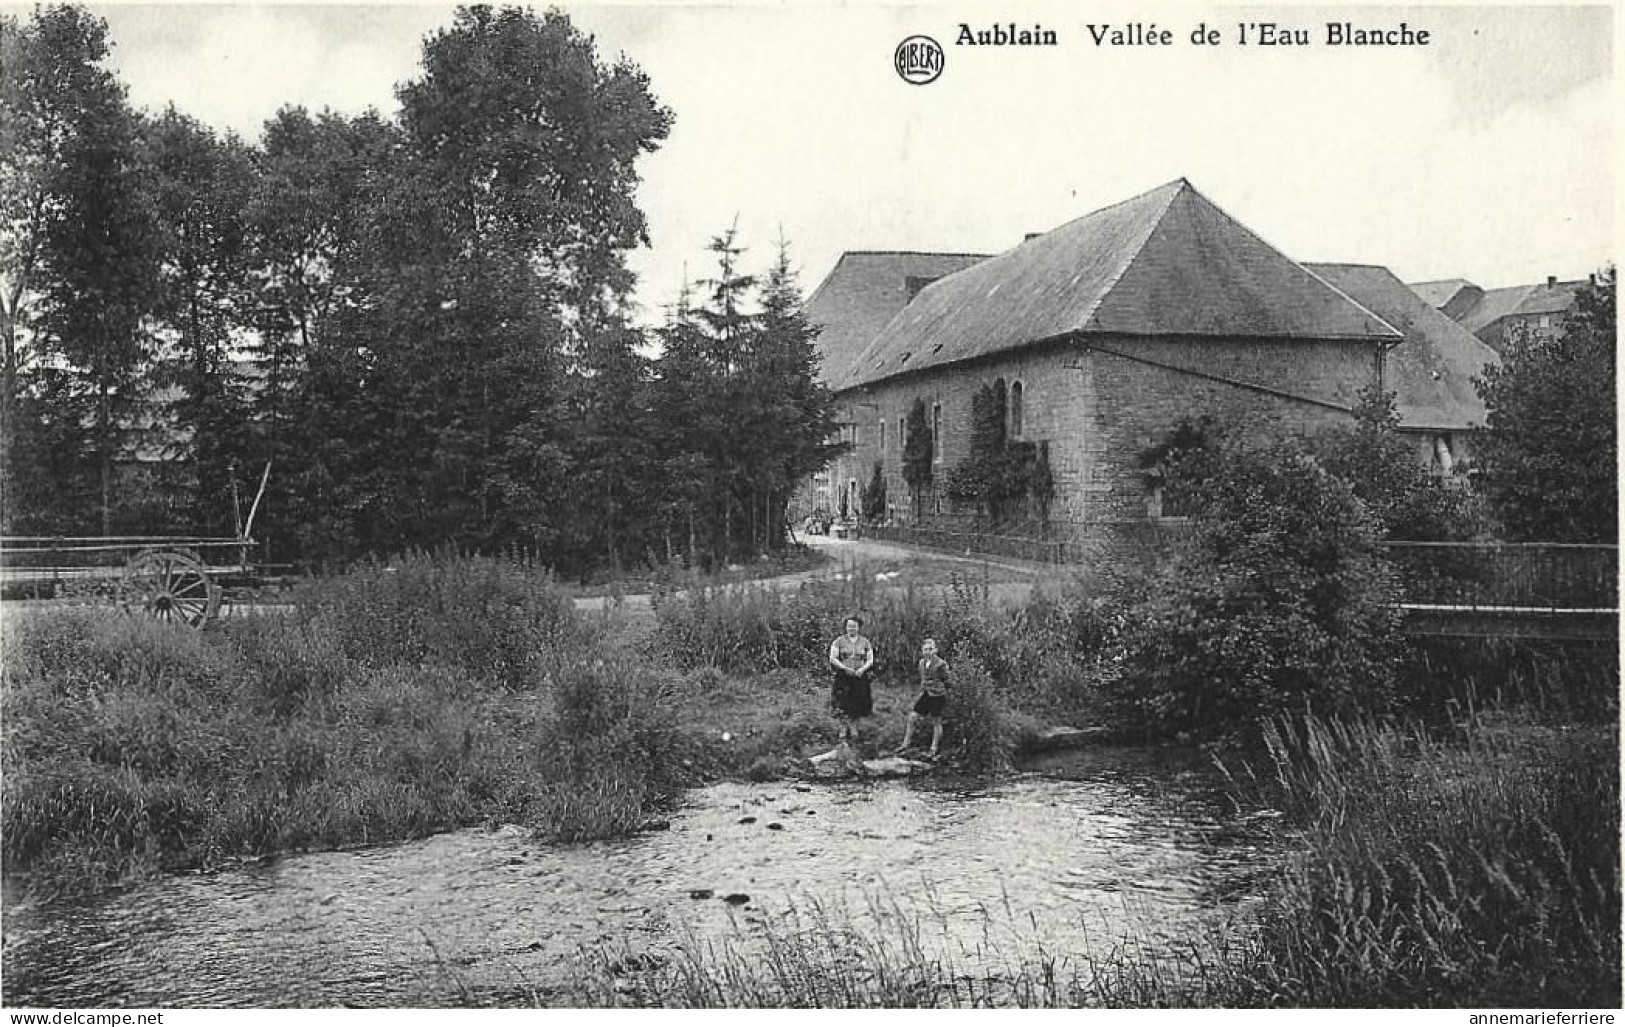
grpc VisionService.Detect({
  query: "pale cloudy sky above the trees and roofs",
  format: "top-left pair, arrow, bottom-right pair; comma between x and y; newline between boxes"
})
60,0 -> 1620,322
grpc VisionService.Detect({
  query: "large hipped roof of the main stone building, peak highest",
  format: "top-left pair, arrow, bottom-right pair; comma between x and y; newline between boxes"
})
830,179 -> 1399,390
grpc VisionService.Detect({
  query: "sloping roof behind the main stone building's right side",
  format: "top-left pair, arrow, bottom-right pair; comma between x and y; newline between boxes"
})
1305,263 -> 1500,431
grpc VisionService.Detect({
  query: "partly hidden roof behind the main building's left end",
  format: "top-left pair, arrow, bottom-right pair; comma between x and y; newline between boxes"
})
804,250 -> 988,385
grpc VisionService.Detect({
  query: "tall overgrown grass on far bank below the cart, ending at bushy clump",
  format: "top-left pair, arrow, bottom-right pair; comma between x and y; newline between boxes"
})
0,557 -> 687,891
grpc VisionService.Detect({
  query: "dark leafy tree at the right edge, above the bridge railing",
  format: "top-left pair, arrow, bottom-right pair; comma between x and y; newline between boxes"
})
1474,267 -> 1619,543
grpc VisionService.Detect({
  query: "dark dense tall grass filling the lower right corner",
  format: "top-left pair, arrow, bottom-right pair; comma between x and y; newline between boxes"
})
1238,718 -> 1620,1006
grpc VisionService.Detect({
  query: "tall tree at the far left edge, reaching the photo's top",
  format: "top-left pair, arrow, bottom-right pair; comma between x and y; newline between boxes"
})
0,7 -> 156,533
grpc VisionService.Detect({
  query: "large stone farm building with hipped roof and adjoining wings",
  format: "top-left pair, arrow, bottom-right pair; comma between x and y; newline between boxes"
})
808,179 -> 1495,523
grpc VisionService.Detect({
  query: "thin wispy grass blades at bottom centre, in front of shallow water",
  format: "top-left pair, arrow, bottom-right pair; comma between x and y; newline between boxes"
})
574,892 -> 1232,1009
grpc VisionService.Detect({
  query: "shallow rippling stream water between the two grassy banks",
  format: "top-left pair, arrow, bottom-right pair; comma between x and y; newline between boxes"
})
3,749 -> 1271,1008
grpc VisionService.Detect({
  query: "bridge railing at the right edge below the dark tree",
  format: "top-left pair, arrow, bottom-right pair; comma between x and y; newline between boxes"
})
1385,543 -> 1619,609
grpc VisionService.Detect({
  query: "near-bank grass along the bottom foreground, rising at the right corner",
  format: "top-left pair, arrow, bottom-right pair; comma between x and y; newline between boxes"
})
579,708 -> 1620,1008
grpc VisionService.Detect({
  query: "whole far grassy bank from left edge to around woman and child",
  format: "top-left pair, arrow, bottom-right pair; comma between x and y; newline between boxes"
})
0,557 -> 1053,892
